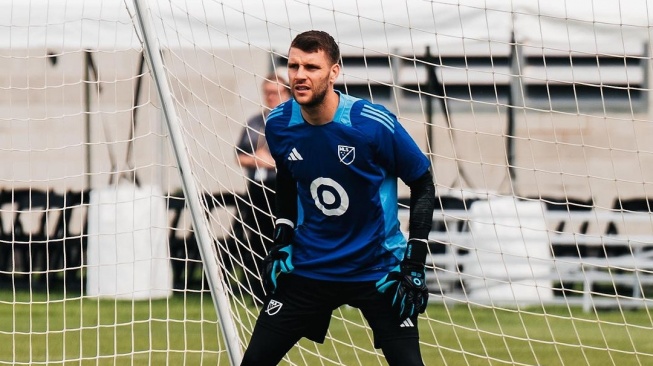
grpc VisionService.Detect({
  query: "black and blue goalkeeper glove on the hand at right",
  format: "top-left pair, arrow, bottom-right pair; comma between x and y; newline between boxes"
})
376,239 -> 429,319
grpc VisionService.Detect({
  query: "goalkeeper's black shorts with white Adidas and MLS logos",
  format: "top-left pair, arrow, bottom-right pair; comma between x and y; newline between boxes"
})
252,274 -> 419,348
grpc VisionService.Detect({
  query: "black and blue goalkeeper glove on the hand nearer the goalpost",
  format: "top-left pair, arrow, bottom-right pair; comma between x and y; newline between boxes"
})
263,220 -> 295,295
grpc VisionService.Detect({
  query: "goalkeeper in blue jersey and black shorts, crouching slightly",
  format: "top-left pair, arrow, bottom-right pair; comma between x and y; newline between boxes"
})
242,31 -> 435,365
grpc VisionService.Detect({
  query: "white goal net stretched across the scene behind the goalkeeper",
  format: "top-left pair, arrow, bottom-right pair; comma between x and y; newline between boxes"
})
0,0 -> 653,365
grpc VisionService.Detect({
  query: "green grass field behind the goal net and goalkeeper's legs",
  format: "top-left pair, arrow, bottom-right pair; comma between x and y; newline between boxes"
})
0,290 -> 653,365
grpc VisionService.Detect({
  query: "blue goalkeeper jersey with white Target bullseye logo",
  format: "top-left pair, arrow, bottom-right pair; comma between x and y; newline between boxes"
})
265,92 -> 430,281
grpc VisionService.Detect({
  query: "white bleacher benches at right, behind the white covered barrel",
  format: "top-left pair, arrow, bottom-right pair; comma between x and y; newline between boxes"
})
399,197 -> 653,311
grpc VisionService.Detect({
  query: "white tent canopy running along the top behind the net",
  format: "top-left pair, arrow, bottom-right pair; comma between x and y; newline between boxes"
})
0,0 -> 653,54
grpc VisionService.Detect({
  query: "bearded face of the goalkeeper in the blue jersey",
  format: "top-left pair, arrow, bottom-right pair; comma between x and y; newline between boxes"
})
288,48 -> 340,107
